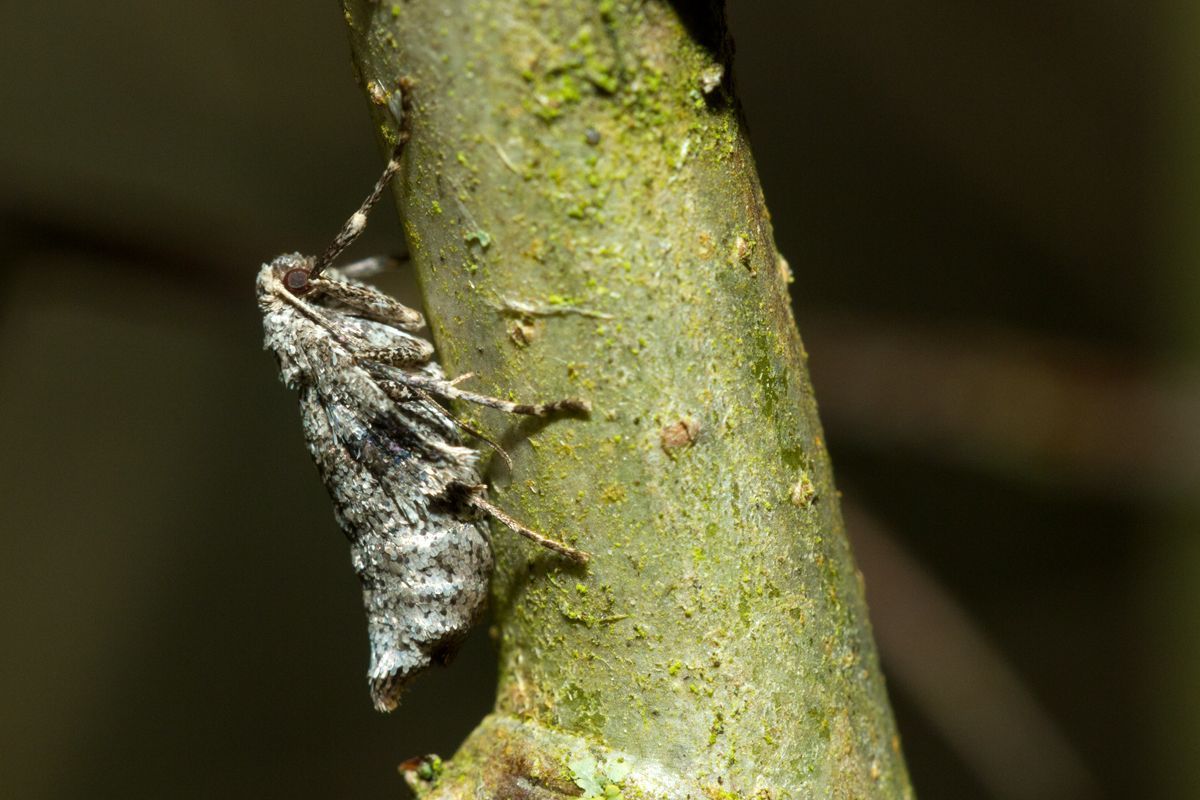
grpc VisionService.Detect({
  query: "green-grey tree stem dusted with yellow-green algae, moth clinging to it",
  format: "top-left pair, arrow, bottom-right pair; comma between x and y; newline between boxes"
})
346,0 -> 911,799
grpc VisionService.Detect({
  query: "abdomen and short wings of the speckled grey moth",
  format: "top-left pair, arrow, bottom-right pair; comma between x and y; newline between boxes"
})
300,369 -> 492,710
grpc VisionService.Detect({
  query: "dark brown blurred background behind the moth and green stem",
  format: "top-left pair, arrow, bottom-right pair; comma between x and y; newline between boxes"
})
0,0 -> 1200,800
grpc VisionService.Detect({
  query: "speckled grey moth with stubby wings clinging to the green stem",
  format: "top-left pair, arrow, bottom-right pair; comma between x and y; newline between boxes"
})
257,125 -> 589,711
